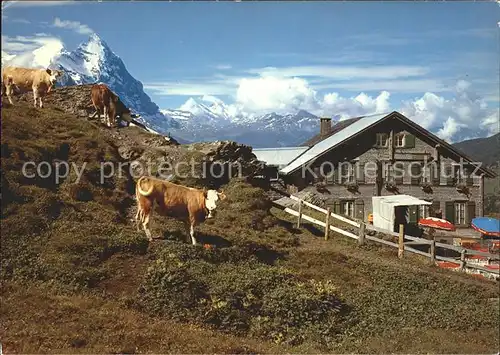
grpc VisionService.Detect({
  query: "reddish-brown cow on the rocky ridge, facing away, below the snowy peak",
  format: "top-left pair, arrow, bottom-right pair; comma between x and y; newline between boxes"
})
91,84 -> 132,127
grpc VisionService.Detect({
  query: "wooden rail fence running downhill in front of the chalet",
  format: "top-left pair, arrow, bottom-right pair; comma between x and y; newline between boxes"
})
274,195 -> 500,278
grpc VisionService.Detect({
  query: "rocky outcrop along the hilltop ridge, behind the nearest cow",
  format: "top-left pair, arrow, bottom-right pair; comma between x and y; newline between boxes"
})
11,85 -> 264,187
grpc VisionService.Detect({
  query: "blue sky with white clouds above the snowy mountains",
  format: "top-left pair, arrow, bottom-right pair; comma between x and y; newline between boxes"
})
2,1 -> 500,142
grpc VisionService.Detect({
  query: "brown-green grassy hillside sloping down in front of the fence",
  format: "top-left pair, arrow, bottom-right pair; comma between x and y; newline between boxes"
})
0,96 -> 500,353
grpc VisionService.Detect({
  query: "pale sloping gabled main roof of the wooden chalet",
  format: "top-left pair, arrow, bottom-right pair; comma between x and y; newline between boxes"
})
280,111 -> 496,177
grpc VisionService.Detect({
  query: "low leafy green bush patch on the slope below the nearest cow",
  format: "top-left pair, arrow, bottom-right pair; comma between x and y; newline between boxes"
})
138,243 -> 350,344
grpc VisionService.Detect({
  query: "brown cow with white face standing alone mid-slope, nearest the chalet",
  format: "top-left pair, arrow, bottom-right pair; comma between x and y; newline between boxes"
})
135,176 -> 226,245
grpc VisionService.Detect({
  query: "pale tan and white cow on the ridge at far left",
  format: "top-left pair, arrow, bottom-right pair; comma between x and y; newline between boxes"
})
2,66 -> 62,108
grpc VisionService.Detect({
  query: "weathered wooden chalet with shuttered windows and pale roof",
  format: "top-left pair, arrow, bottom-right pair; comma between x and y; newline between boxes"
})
253,111 -> 495,227
